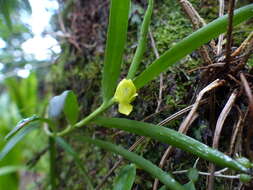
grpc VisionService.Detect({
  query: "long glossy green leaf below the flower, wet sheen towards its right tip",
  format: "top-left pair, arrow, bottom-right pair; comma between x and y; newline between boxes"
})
93,117 -> 249,173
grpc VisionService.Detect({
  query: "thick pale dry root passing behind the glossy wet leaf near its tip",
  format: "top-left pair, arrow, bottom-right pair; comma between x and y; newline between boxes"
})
208,91 -> 237,190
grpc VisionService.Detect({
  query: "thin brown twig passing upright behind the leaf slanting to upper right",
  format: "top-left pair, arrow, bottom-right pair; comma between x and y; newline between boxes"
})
149,29 -> 163,113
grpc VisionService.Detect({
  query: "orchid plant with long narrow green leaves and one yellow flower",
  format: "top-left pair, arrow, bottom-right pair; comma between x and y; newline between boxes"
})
0,0 -> 253,190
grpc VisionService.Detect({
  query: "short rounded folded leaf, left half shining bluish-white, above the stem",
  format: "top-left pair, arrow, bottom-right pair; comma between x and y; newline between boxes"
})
48,90 -> 79,125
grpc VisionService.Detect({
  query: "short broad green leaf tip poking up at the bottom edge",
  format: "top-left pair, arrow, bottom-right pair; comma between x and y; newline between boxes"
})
113,164 -> 136,190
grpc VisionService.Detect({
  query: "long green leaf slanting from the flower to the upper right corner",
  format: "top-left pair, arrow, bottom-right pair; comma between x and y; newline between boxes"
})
134,4 -> 253,88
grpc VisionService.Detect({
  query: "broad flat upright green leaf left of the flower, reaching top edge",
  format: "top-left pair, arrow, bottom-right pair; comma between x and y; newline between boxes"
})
102,0 -> 130,102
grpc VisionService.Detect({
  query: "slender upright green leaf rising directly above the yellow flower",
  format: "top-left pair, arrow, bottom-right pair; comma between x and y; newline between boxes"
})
127,0 -> 154,79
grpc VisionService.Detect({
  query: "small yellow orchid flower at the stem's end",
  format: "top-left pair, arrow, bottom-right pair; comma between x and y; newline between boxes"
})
114,79 -> 138,115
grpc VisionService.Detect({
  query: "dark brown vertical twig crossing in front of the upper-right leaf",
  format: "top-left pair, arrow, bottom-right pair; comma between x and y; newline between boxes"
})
226,0 -> 235,64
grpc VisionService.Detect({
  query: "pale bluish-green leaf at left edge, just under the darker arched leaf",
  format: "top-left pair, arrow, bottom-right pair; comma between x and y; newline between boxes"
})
0,125 -> 39,160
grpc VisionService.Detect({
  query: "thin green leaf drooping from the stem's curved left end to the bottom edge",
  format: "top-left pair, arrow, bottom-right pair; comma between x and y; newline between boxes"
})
56,137 -> 94,189
